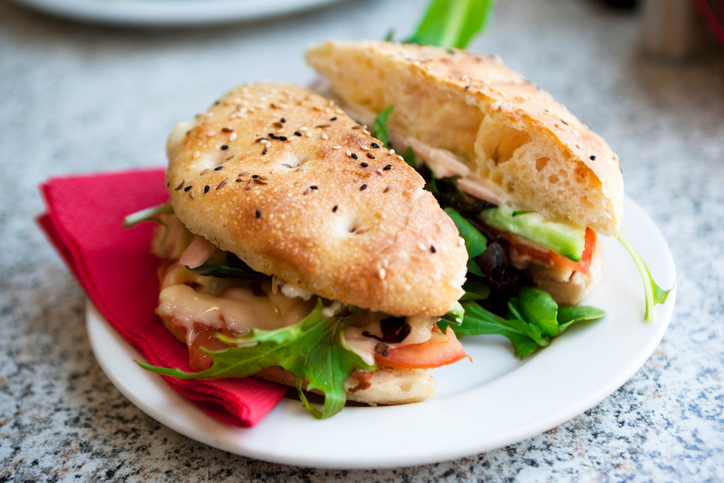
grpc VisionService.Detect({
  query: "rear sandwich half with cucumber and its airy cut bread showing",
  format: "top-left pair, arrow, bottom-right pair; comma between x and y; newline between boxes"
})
306,41 -> 624,306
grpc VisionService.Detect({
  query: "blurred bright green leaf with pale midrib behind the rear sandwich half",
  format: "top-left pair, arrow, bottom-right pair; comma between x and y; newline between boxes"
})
407,0 -> 495,49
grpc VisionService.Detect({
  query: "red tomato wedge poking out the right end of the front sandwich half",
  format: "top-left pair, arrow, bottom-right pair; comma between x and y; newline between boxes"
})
375,327 -> 472,369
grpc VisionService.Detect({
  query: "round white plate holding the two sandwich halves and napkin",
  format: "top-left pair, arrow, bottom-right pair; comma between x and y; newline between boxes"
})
87,199 -> 676,468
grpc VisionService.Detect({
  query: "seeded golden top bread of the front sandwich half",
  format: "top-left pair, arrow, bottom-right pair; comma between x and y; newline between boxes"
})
166,83 -> 467,316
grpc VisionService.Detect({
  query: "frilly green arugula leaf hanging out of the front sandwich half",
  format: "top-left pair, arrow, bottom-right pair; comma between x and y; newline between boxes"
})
136,300 -> 375,419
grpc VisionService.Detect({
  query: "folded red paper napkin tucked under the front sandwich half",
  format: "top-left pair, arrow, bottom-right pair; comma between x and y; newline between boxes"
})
38,169 -> 287,427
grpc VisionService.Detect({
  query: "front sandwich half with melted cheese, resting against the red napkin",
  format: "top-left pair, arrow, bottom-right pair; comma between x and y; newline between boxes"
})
133,83 -> 468,418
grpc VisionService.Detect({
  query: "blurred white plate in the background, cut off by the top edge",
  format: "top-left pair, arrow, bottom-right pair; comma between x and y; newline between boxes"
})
14,0 -> 350,27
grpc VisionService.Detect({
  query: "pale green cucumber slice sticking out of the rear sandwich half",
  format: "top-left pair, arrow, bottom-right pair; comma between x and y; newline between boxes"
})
479,206 -> 586,262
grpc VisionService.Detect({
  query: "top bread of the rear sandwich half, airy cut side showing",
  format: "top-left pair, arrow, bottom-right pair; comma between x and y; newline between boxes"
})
306,41 -> 623,235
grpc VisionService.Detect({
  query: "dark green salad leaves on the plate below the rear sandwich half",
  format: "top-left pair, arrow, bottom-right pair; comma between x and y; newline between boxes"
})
438,287 -> 606,359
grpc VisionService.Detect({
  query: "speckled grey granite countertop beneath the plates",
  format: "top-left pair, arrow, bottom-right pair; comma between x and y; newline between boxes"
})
0,0 -> 724,482
